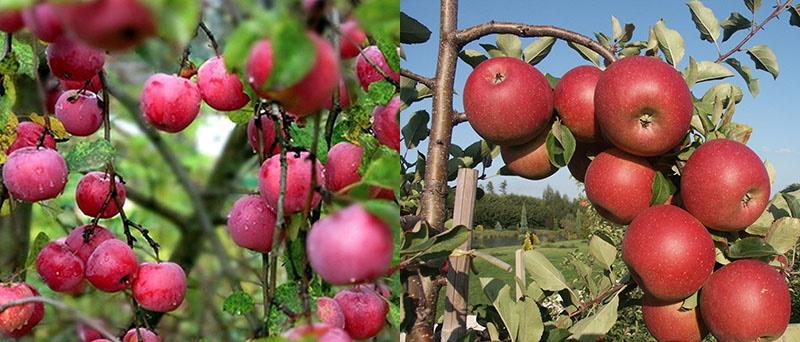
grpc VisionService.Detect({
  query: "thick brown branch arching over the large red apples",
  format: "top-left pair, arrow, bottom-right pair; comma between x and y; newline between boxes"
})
455,21 -> 617,63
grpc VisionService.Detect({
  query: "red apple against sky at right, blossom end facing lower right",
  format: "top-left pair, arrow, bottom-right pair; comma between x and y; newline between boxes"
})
681,139 -> 770,232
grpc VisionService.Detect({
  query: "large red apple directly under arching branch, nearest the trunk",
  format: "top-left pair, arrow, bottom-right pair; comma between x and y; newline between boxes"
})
463,57 -> 553,146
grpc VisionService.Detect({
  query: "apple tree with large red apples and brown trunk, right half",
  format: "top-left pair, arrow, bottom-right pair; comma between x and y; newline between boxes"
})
400,0 -> 800,341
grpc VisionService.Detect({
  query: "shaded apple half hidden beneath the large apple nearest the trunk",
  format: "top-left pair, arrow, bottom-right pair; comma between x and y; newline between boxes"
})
500,132 -> 558,179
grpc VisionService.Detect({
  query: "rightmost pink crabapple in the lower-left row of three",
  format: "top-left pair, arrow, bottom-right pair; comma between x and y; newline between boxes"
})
131,262 -> 186,312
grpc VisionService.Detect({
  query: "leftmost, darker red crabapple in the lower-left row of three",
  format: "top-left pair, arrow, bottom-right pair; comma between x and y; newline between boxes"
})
36,241 -> 83,292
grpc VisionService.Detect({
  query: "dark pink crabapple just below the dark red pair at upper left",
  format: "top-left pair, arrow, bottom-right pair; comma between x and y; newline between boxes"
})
55,90 -> 103,137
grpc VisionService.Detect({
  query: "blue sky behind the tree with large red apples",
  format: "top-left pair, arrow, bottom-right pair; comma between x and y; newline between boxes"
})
400,0 -> 800,197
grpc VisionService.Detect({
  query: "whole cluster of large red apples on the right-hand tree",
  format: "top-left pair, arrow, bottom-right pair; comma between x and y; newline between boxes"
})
464,56 -> 790,341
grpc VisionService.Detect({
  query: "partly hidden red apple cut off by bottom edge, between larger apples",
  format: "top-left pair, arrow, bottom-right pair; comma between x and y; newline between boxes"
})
642,294 -> 708,342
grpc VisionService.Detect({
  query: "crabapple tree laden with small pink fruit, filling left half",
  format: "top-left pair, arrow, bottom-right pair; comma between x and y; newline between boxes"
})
0,0 -> 401,342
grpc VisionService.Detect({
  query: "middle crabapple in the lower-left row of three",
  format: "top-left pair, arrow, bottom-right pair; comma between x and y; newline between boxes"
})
86,239 -> 139,292
